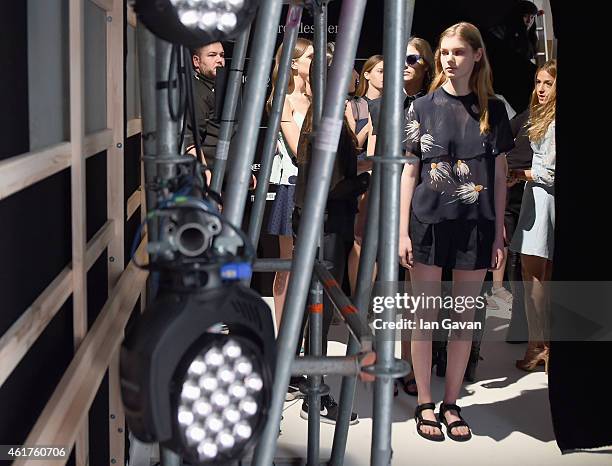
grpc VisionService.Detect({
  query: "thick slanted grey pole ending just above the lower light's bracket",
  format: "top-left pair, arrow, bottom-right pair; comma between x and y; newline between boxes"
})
223,0 -> 282,232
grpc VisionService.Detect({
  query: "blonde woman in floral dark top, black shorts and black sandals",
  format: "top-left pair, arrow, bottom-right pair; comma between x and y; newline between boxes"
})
399,23 -> 513,441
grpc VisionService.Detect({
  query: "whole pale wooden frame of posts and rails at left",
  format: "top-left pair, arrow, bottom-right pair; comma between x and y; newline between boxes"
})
0,0 -> 147,466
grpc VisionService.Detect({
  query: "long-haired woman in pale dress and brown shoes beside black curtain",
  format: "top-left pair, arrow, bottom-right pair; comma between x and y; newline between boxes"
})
510,60 -> 557,371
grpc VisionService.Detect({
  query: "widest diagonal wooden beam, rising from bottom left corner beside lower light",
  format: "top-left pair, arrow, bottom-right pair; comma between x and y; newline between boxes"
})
13,240 -> 148,466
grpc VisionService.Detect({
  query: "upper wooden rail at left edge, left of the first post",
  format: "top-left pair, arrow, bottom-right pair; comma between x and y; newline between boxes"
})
0,142 -> 72,200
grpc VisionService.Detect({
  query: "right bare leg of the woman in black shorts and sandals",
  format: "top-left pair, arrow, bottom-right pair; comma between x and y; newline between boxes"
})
444,269 -> 487,435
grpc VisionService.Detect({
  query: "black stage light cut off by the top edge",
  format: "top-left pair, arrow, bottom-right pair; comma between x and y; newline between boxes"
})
134,0 -> 259,48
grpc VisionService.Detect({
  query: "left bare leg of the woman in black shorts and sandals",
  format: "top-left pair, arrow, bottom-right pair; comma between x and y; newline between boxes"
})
410,262 -> 442,435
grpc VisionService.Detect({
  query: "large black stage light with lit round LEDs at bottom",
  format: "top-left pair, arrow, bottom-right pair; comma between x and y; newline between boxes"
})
121,282 -> 276,465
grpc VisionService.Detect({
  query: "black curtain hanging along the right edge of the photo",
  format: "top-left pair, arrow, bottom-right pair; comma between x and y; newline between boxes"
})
548,0 -> 612,453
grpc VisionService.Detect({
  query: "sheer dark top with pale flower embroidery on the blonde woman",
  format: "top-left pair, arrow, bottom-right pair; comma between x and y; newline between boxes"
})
404,87 -> 514,223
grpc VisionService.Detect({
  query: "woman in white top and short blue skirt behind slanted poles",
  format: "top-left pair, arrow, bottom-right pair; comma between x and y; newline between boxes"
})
267,38 -> 314,328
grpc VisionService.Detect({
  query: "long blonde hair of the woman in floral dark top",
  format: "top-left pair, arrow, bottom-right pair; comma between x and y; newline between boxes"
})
429,22 -> 495,134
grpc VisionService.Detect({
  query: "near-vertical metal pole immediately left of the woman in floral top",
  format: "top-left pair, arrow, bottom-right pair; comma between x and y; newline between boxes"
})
371,0 -> 407,466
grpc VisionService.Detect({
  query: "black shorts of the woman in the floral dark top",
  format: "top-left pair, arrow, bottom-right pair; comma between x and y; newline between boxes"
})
410,214 -> 495,270
